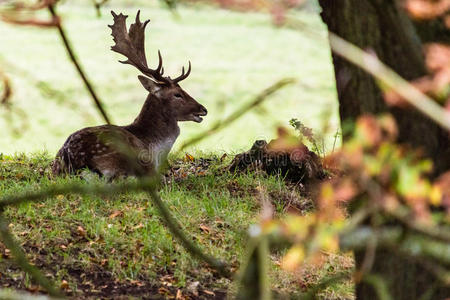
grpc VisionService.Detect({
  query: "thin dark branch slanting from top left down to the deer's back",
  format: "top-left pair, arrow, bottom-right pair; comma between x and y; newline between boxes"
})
48,4 -> 111,124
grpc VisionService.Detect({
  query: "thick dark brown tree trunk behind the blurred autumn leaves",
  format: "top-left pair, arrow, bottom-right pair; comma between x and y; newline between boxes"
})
319,0 -> 450,300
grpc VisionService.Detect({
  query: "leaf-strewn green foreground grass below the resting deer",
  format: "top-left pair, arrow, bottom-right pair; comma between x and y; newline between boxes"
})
0,154 -> 352,299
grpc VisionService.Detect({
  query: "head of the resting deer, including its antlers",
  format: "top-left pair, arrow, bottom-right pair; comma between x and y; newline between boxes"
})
109,11 -> 207,123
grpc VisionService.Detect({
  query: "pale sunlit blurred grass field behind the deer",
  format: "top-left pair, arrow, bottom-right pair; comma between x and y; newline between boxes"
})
0,1 -> 339,155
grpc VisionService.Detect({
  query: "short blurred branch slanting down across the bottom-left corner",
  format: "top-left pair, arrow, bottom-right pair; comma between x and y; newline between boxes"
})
0,214 -> 62,297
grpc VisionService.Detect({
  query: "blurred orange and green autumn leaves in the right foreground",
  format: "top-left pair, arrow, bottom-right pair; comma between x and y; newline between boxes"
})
243,115 -> 450,298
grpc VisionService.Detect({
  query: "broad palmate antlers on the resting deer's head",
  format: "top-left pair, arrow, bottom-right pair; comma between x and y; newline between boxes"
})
108,10 -> 191,83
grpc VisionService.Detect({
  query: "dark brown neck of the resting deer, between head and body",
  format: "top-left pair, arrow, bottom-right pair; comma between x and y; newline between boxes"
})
124,95 -> 180,151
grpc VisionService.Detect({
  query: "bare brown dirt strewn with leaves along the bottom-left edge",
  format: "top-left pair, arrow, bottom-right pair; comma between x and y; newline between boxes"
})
0,243 -> 226,299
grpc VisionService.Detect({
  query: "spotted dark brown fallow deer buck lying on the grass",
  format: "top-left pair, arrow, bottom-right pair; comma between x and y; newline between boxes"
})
52,11 -> 207,179
